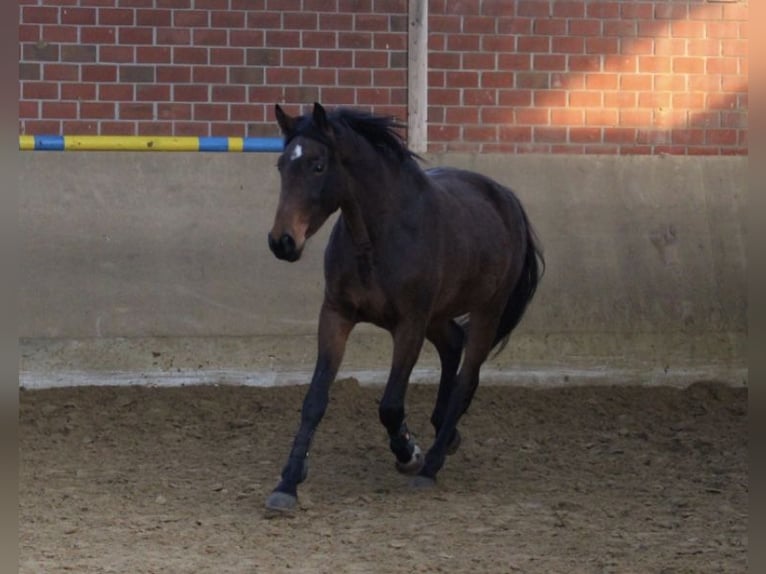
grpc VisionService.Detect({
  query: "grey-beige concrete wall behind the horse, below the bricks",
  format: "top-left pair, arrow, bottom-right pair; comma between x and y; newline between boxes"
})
19,153 -> 747,387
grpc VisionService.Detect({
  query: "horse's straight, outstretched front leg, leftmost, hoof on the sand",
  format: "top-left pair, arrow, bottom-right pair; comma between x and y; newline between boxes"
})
266,302 -> 354,511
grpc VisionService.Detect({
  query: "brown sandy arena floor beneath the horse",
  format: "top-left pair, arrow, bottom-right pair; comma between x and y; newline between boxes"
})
19,380 -> 748,574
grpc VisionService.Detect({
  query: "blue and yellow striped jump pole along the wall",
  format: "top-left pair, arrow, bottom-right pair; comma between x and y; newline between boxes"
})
19,135 -> 283,152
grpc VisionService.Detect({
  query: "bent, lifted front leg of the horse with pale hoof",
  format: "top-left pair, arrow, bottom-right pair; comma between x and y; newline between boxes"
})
378,324 -> 425,474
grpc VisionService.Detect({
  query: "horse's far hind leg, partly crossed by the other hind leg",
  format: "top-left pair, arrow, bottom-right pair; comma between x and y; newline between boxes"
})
426,320 -> 465,454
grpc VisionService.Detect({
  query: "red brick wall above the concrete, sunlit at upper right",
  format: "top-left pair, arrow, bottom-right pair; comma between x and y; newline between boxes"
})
19,0 -> 748,155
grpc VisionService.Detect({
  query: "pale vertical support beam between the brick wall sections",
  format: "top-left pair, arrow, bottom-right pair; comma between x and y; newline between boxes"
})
407,0 -> 428,153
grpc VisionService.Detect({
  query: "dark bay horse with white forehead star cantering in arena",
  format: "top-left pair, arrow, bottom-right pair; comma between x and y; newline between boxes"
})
266,103 -> 544,511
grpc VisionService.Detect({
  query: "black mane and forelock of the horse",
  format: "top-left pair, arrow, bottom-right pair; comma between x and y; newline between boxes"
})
285,108 -> 421,162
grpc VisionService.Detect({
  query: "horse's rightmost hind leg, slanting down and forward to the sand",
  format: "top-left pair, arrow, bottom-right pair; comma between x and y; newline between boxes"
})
415,312 -> 499,486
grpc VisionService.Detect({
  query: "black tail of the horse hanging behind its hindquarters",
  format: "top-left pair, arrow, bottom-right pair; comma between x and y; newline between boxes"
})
492,198 -> 545,354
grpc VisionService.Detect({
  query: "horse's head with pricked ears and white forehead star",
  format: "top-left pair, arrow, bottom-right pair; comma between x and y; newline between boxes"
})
269,103 -> 340,261
